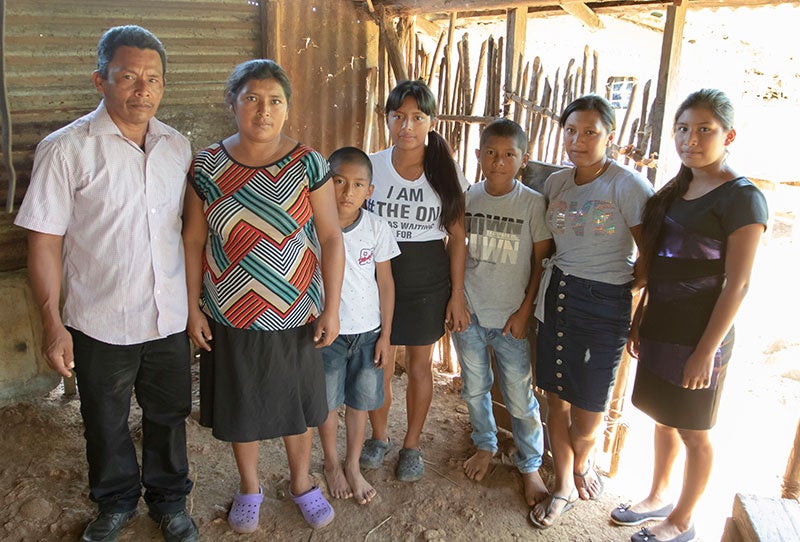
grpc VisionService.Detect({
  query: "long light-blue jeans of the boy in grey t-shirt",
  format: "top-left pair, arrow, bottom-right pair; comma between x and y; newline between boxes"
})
453,314 -> 544,473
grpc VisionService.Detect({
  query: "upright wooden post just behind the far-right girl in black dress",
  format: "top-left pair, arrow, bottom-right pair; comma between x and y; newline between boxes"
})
642,0 -> 689,186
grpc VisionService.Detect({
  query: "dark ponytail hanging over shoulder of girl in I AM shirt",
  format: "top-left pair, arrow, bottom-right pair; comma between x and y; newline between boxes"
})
423,130 -> 464,228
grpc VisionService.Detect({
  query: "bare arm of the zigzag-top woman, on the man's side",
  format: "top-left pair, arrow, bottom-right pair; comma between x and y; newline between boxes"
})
181,188 -> 212,351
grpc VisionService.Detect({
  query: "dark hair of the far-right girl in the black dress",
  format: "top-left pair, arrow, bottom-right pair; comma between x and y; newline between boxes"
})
639,88 -> 733,271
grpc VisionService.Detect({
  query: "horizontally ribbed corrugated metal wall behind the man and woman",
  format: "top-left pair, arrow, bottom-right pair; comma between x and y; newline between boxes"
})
0,0 -> 260,208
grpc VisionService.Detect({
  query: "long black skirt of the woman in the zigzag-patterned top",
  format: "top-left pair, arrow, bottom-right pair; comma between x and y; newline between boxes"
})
200,319 -> 328,442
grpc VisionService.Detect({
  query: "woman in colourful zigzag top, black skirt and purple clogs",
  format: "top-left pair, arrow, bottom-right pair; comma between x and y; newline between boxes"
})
183,59 -> 344,533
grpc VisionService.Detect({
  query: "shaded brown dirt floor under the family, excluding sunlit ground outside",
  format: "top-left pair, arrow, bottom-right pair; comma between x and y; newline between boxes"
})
0,366 -> 634,541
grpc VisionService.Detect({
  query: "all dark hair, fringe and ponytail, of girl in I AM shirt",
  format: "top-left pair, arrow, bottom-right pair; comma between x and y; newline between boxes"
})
386,81 -> 464,227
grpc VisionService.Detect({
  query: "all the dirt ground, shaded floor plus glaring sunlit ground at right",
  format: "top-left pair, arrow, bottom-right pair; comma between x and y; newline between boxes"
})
0,209 -> 800,542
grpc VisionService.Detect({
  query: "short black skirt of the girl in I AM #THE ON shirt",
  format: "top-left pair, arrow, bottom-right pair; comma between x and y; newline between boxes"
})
391,241 -> 450,346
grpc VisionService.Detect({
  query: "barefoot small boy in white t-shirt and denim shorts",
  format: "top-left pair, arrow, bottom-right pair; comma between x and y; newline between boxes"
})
319,147 -> 400,504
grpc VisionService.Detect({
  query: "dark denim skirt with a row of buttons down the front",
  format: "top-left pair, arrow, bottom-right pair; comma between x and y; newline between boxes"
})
536,266 -> 631,412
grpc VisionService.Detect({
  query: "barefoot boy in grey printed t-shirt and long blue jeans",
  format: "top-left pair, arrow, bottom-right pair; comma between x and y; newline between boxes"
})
453,119 -> 552,506
